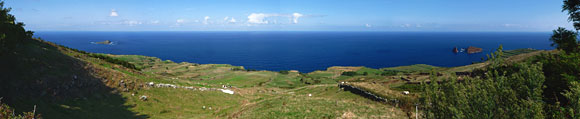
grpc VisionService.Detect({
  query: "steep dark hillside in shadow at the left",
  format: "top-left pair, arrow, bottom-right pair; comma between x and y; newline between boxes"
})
0,40 -> 143,118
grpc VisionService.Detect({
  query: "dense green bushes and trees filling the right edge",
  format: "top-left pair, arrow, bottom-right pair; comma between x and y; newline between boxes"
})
421,0 -> 580,119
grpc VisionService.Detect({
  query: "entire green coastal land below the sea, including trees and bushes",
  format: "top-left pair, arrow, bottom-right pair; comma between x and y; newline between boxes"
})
0,0 -> 580,119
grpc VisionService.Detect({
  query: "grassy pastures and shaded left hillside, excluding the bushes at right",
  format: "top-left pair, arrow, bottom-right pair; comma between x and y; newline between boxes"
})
0,37 -> 548,119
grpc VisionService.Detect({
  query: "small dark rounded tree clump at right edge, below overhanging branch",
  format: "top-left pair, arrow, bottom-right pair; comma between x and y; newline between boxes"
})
550,27 -> 579,53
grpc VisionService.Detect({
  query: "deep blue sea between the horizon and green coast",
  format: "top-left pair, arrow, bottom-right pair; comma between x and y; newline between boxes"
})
35,31 -> 554,72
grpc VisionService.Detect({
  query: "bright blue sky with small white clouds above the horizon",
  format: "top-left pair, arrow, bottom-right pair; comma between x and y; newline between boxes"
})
5,0 -> 572,32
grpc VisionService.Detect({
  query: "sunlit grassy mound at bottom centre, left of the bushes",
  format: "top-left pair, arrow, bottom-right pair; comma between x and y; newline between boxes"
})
240,85 -> 406,118
